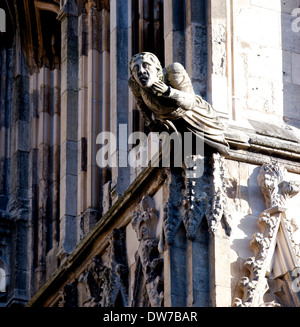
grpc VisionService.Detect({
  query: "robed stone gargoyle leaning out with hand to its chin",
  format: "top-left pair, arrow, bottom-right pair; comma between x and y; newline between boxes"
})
129,52 -> 229,154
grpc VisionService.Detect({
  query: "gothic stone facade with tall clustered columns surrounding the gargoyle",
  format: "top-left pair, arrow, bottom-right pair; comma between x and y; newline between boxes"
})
0,0 -> 300,307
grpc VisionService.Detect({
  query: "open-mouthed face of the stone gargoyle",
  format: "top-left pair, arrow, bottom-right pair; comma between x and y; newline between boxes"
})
131,58 -> 159,88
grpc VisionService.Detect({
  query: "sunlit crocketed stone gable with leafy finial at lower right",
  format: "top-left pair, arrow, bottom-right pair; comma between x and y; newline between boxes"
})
234,162 -> 300,307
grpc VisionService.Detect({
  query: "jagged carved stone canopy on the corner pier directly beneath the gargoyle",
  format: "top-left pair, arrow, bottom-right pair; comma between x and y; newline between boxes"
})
160,153 -> 231,251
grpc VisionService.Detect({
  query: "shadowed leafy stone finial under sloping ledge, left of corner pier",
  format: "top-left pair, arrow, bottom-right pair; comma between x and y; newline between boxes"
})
131,196 -> 164,307
